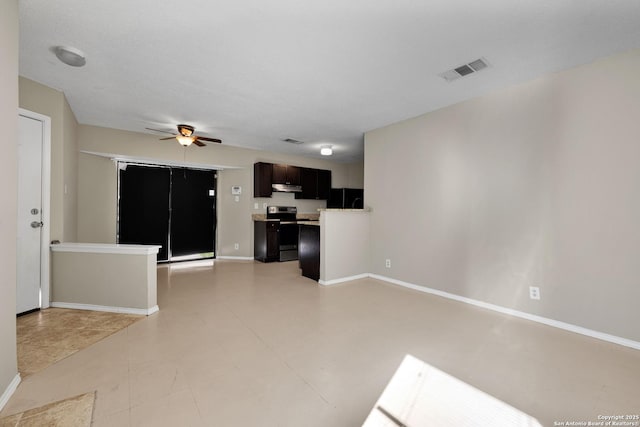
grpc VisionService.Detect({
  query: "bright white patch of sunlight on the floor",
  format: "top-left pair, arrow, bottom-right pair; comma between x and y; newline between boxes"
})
363,355 -> 542,427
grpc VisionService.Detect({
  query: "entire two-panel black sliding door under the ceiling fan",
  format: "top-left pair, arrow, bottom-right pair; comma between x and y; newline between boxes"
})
118,165 -> 216,261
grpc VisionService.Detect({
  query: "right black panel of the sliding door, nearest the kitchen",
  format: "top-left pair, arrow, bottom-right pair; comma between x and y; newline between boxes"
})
171,168 -> 216,258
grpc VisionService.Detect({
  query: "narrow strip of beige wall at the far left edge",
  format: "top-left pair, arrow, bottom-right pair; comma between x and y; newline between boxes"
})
0,0 -> 18,402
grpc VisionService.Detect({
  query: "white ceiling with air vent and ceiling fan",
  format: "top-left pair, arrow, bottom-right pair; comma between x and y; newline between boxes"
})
19,0 -> 640,162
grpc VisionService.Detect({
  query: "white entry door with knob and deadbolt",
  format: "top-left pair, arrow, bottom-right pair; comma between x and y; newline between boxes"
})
16,115 -> 44,313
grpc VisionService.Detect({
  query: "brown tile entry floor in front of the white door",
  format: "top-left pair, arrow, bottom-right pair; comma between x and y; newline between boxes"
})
16,308 -> 143,379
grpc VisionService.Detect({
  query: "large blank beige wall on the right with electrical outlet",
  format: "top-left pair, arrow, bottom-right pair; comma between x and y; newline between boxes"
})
365,51 -> 640,341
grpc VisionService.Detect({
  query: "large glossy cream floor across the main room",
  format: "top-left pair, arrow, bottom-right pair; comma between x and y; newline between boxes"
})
0,261 -> 640,426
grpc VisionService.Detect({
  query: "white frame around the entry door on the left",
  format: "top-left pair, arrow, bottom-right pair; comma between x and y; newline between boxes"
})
16,108 -> 51,308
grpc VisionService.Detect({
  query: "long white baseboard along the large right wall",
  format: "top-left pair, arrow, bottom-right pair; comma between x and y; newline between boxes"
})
368,274 -> 640,350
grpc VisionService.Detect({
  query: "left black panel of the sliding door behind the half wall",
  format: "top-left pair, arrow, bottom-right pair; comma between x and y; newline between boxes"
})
118,165 -> 171,261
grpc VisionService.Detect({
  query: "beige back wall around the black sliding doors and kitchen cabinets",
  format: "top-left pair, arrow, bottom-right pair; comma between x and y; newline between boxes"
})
78,125 -> 363,257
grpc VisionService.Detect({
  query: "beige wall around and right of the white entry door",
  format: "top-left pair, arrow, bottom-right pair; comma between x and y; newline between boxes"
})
20,77 -> 78,242
